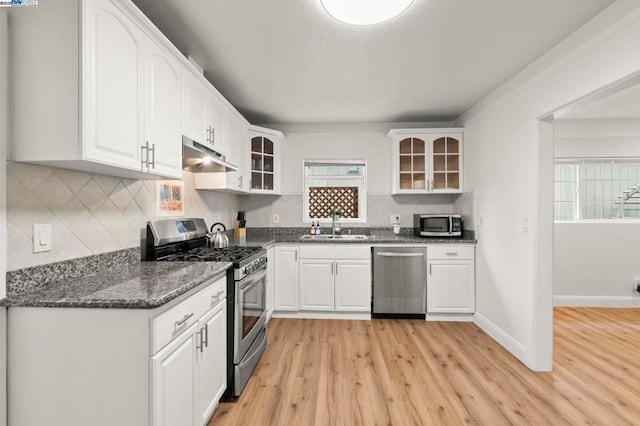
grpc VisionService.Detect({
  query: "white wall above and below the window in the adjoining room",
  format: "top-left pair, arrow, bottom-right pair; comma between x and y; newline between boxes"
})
553,119 -> 640,306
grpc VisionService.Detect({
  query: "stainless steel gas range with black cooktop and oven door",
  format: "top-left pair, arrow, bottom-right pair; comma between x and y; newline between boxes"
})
143,218 -> 267,400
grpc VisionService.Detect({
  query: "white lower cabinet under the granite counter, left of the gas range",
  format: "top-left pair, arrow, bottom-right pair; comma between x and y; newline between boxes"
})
7,274 -> 227,426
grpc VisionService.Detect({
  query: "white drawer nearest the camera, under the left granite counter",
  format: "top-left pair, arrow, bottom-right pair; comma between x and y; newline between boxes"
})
151,293 -> 204,354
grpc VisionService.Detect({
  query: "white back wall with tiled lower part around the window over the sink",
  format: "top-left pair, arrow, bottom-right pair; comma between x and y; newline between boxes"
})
242,123 -> 464,227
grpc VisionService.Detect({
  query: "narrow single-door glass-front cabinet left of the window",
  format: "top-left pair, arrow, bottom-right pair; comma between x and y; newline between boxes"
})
249,126 -> 284,194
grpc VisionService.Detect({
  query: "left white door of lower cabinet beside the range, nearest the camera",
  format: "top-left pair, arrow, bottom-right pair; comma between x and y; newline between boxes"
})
151,324 -> 198,426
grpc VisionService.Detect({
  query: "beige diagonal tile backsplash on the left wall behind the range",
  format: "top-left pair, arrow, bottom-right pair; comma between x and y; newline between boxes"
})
7,163 -> 239,270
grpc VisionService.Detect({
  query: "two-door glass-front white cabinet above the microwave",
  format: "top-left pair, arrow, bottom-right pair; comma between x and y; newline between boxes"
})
387,129 -> 463,194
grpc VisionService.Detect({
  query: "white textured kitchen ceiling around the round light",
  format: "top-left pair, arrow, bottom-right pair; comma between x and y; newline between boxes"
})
133,0 -> 613,124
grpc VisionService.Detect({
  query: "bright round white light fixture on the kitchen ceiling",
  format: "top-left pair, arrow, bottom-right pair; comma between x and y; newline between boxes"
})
320,0 -> 413,25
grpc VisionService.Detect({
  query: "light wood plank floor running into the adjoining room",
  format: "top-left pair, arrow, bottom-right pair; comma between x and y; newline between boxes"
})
209,308 -> 640,426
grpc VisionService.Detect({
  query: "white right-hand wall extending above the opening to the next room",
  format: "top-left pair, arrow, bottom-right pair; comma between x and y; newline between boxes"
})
458,0 -> 640,370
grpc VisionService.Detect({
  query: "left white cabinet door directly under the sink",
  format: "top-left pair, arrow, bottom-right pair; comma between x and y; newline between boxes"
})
300,259 -> 335,311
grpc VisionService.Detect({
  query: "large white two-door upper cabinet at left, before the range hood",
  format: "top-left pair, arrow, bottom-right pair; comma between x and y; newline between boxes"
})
10,0 -> 182,179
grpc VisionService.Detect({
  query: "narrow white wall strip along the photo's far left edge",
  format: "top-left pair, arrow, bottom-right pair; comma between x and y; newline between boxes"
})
0,10 -> 9,426
